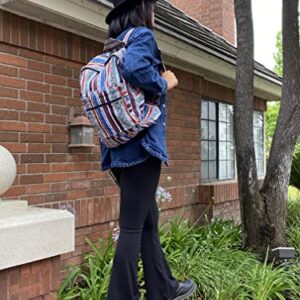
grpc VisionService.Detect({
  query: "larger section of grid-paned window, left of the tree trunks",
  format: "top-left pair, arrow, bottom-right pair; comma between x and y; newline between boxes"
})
201,100 -> 235,180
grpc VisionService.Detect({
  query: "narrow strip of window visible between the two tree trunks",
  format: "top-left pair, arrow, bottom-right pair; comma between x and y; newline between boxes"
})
253,111 -> 265,176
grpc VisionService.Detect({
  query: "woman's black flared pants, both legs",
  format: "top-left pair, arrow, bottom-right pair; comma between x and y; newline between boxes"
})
107,156 -> 178,300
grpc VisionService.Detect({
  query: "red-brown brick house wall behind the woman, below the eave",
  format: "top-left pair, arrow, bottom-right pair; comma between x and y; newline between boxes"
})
0,11 -> 266,296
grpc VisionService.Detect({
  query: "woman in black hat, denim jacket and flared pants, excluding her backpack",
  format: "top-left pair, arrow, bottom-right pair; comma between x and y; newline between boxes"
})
100,0 -> 196,300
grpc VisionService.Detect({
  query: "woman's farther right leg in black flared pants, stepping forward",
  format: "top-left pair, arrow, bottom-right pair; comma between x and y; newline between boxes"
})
141,199 -> 179,300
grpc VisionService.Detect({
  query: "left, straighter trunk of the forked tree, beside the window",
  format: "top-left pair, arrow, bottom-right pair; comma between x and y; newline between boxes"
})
234,0 -> 263,255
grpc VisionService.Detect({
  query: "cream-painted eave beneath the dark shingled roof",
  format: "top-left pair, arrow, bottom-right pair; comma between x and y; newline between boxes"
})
0,0 -> 281,101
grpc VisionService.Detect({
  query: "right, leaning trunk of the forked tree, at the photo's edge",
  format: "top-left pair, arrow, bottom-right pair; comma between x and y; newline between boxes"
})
260,0 -> 300,252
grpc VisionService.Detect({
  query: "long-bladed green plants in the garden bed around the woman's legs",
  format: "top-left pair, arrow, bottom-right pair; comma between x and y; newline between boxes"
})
58,189 -> 300,300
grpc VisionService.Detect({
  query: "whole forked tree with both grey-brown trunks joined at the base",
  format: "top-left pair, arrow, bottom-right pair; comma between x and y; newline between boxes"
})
234,0 -> 300,259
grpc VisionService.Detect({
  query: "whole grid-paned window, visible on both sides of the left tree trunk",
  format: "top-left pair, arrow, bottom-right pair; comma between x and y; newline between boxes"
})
201,99 -> 264,180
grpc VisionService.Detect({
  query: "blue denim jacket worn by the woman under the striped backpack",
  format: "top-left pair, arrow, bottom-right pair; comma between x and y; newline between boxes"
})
100,27 -> 169,171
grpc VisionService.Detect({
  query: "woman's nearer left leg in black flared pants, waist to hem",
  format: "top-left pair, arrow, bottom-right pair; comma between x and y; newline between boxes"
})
107,156 -> 161,300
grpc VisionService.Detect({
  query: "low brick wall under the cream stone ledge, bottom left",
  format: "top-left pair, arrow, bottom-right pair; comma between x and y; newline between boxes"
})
0,256 -> 60,300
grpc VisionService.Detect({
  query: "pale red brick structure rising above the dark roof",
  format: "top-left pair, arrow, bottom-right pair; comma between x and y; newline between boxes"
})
170,0 -> 235,44
